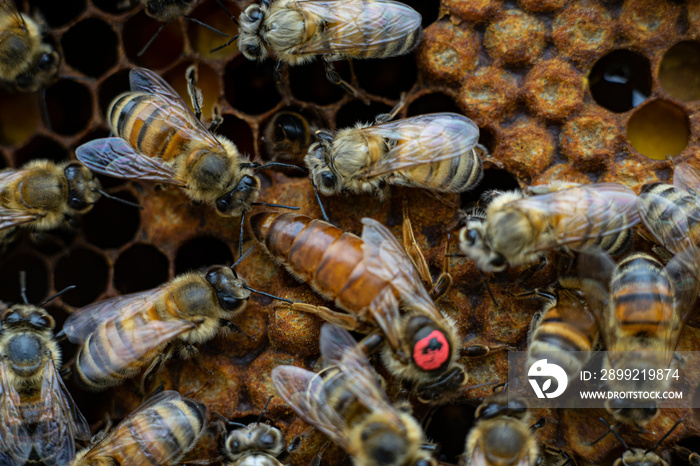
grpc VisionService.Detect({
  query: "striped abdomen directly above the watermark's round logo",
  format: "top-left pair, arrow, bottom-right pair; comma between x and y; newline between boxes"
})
528,297 -> 598,377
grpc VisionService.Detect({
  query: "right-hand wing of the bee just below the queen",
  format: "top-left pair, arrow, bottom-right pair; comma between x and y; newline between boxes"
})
321,324 -> 401,423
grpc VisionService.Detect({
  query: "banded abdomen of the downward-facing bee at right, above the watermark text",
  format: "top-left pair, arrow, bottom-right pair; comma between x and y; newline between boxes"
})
608,253 -> 674,344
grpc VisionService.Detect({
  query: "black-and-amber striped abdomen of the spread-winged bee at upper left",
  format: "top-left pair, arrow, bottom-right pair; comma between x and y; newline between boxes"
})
107,92 -> 198,162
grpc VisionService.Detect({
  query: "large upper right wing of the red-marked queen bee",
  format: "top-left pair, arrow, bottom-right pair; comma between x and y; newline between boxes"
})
362,218 -> 443,322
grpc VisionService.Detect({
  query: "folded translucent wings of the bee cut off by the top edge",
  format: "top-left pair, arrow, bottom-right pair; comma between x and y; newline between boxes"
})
294,0 -> 421,54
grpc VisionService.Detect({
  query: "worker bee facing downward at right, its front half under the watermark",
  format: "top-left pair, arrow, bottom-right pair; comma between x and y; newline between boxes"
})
579,249 -> 699,426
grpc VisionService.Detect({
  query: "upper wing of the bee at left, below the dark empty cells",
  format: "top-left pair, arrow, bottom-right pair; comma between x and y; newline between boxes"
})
63,285 -> 171,344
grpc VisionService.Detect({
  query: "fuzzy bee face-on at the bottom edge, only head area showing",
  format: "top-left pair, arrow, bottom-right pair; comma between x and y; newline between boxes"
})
223,397 -> 284,466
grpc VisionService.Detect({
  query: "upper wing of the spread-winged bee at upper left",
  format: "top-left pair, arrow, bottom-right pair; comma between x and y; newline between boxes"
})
129,68 -> 224,151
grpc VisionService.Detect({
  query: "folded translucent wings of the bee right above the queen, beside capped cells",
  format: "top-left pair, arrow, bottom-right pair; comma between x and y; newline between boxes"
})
362,113 -> 479,177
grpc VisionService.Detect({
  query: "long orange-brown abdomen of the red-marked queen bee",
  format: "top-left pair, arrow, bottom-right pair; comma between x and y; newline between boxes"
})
250,212 -> 390,313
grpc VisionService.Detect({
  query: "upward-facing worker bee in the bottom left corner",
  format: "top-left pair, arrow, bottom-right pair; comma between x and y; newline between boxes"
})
0,294 -> 90,465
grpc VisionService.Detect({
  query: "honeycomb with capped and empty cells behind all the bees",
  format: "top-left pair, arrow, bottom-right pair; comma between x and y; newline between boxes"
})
0,0 -> 700,465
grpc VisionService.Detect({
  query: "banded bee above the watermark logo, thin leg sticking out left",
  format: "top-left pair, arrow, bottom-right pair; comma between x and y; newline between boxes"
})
521,277 -> 598,380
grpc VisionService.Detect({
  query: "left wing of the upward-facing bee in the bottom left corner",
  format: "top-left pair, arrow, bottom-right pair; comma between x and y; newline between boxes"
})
0,361 -> 32,464
